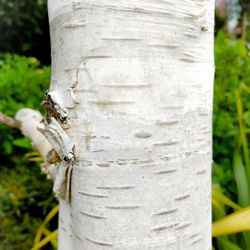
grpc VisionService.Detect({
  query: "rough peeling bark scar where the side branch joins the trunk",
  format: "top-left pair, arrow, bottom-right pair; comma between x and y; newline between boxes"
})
37,92 -> 75,202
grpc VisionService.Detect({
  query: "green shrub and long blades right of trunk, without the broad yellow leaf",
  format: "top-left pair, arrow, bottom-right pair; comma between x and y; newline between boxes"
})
213,32 -> 250,250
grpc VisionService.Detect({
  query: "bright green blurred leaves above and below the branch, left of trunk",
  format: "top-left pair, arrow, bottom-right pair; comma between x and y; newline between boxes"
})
0,54 -> 50,157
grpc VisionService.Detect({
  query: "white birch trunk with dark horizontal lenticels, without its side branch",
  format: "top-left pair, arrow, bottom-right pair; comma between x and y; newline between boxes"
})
46,0 -> 214,250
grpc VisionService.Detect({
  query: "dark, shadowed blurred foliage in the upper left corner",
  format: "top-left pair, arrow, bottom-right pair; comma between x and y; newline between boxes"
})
0,0 -> 50,64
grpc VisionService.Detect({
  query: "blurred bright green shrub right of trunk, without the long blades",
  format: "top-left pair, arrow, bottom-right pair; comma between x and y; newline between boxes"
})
213,33 -> 250,193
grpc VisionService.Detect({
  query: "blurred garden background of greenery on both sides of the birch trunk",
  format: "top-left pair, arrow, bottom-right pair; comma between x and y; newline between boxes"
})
0,0 -> 250,250
